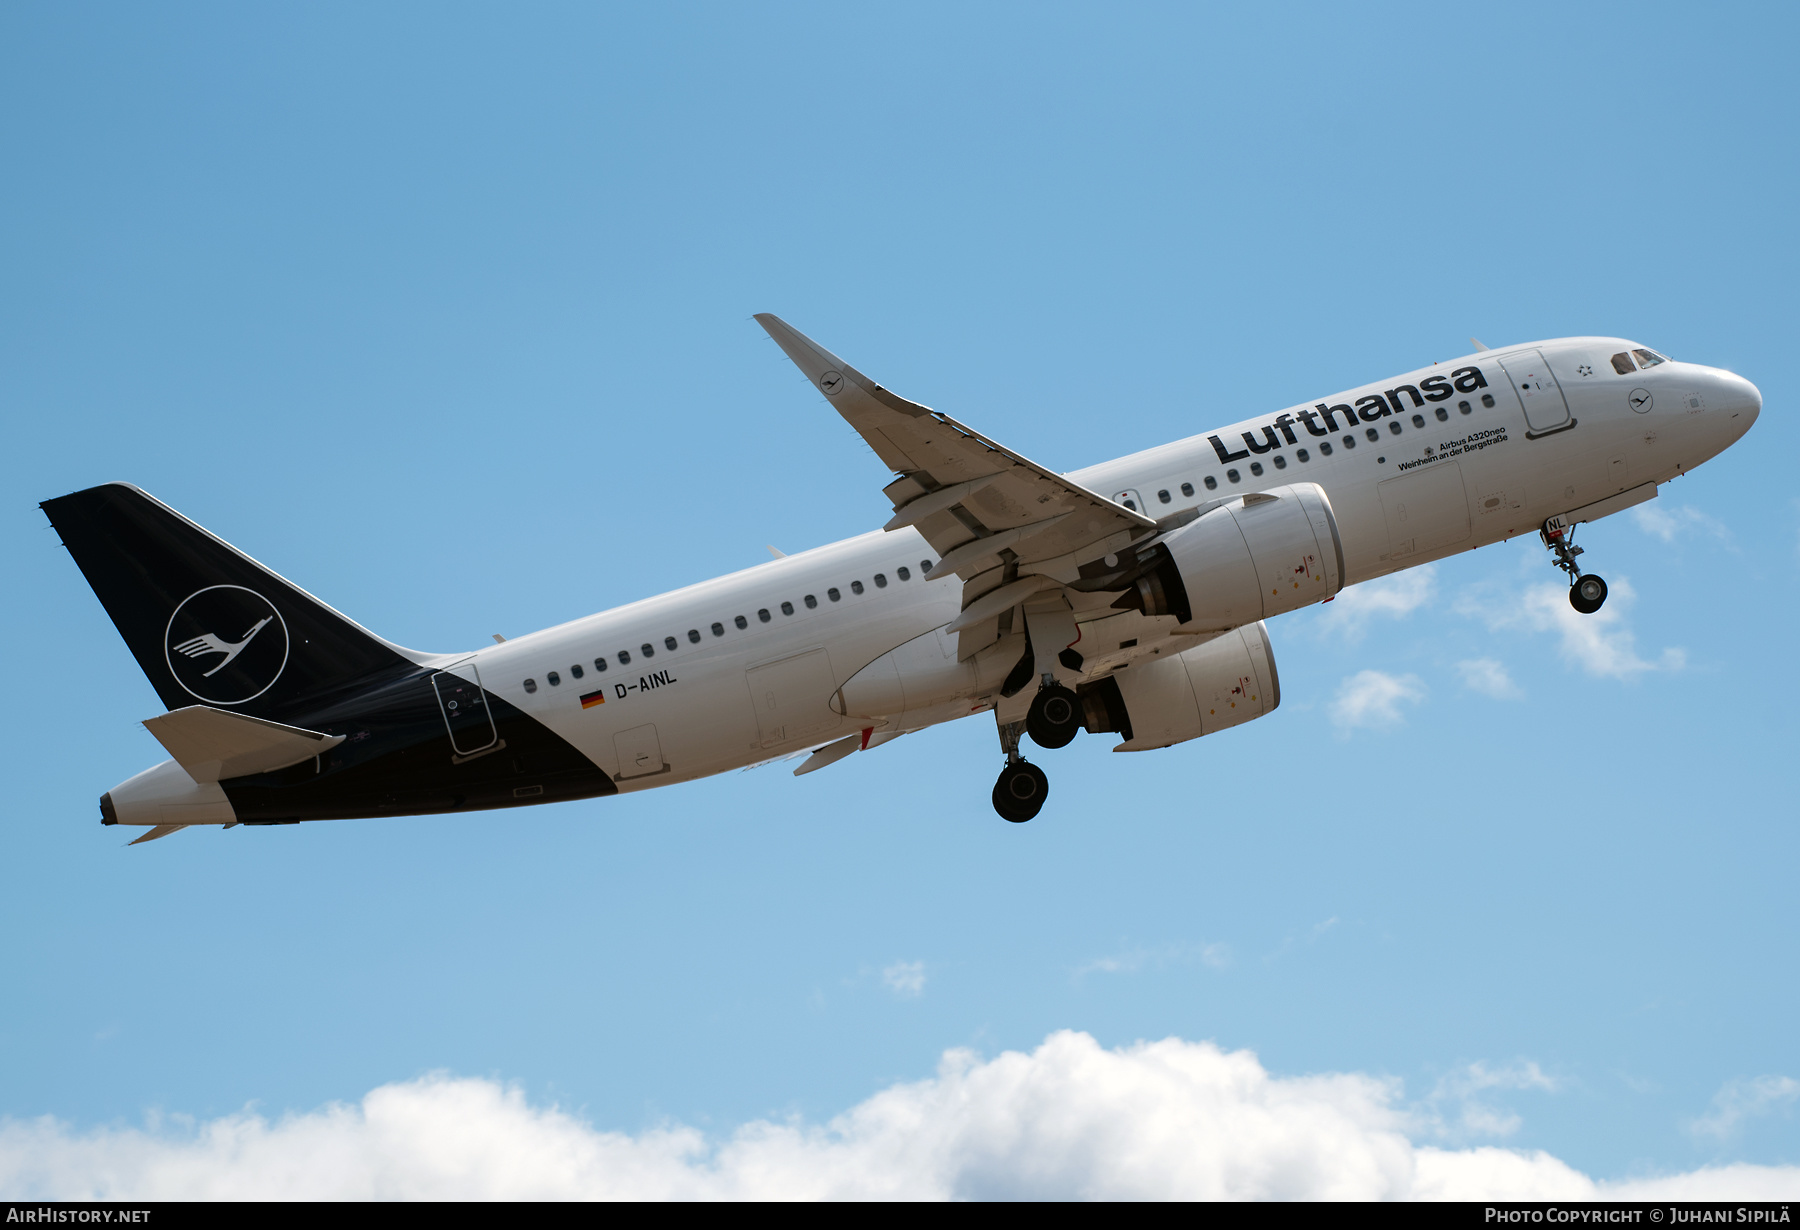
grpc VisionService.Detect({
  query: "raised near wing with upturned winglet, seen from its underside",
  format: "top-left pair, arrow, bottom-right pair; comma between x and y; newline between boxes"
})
756,313 -> 1157,590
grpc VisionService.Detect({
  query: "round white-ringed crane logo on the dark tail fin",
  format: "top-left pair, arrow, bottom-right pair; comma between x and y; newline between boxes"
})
162,585 -> 288,704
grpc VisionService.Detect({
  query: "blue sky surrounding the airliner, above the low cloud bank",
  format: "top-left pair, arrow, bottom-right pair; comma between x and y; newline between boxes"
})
0,4 -> 1800,1190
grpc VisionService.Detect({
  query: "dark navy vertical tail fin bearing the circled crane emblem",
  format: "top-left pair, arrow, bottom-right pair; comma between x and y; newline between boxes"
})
40,483 -> 421,720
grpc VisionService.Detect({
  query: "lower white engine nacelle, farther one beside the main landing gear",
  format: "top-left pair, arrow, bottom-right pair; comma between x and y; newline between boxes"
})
1078,621 -> 1282,751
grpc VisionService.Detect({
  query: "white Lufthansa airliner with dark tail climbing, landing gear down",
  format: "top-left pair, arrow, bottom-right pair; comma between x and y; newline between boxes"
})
41,315 -> 1762,845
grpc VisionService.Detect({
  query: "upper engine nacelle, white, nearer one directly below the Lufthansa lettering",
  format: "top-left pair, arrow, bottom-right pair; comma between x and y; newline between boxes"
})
1116,483 -> 1345,630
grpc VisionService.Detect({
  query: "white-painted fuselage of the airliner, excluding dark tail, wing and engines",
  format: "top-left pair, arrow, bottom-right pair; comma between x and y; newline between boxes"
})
446,339 -> 1760,789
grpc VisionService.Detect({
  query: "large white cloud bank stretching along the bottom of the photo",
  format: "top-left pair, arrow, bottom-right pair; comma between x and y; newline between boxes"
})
0,1032 -> 1800,1201
